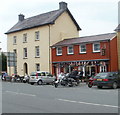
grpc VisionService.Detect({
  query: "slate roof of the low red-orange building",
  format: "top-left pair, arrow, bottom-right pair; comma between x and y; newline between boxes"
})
52,33 -> 116,47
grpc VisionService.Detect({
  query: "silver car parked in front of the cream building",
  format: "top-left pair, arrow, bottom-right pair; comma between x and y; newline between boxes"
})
29,71 -> 55,85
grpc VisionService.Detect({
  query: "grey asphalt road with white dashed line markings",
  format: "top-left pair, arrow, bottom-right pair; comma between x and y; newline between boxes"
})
2,82 -> 118,113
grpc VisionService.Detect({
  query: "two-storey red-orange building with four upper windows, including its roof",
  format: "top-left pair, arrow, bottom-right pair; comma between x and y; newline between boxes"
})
51,33 -> 118,76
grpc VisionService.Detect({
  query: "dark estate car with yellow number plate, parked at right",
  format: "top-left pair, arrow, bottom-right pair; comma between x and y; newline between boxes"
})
94,72 -> 120,89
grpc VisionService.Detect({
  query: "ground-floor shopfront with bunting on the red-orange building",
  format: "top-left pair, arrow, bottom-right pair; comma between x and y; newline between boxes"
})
53,59 -> 109,76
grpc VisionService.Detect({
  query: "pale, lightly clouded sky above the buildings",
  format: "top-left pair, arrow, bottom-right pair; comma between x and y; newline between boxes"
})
0,0 -> 120,52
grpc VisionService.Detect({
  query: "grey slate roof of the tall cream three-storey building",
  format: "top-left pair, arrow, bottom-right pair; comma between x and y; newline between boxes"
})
5,8 -> 81,34
